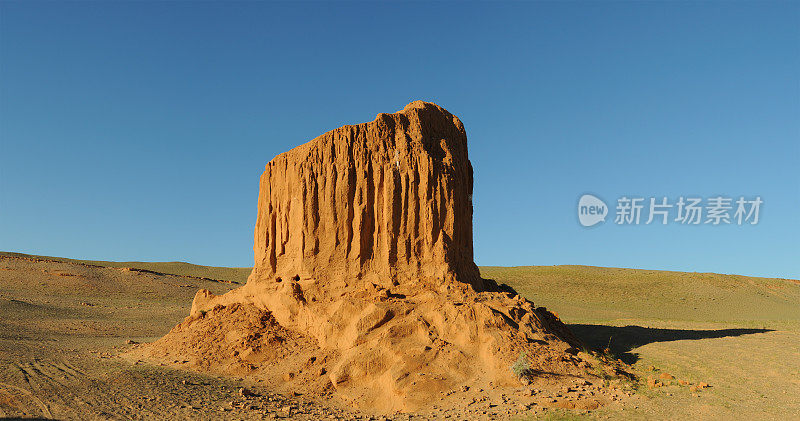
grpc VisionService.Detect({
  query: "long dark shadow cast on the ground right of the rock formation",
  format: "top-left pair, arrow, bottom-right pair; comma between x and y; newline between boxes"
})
568,324 -> 772,364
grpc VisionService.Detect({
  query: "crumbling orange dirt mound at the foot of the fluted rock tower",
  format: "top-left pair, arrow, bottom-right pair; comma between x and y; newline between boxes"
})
134,281 -> 617,412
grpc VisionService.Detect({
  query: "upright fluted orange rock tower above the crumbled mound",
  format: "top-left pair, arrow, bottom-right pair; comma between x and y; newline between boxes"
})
251,101 -> 482,289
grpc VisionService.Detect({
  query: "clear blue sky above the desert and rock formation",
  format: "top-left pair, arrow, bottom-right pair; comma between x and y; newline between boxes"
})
0,1 -> 800,278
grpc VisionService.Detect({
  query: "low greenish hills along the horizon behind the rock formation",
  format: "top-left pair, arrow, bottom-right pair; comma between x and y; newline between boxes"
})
0,252 -> 800,326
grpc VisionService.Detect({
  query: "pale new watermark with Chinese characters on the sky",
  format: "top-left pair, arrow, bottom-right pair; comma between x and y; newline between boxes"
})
578,194 -> 764,227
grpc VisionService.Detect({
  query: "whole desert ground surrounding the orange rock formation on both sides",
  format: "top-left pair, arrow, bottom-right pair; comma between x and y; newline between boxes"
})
0,253 -> 800,419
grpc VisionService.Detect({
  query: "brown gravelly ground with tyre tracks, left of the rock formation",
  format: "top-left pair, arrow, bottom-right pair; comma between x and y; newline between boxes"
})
0,258 -> 354,419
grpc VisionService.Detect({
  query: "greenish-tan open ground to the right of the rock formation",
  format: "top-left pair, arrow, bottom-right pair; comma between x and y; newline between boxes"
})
481,266 -> 800,420
